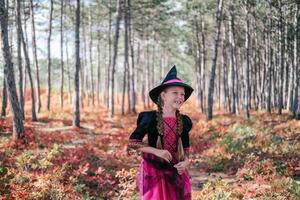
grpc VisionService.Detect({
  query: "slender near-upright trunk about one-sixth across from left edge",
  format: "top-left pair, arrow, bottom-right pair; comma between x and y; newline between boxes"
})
47,0 -> 53,111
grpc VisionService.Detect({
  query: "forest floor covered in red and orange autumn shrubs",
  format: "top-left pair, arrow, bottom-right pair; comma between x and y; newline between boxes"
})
0,96 -> 300,199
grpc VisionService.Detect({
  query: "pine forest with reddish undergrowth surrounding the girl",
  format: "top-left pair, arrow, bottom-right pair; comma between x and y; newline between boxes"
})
0,0 -> 300,199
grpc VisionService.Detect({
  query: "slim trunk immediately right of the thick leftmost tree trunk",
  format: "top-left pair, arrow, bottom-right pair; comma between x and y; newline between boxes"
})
15,0 -> 26,119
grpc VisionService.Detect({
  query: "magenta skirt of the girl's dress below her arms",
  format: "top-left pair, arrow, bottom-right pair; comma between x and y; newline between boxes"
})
137,153 -> 191,200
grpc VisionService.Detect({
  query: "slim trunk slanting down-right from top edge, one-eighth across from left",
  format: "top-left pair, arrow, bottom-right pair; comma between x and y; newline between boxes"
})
30,0 -> 42,112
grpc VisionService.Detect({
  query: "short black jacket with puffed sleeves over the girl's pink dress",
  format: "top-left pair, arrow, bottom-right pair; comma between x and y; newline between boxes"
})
129,111 -> 192,149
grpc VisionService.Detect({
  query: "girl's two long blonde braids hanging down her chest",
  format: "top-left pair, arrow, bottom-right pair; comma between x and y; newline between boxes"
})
156,96 -> 184,161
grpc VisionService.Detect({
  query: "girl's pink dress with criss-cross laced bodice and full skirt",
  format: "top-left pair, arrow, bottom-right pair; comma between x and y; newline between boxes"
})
137,117 -> 191,200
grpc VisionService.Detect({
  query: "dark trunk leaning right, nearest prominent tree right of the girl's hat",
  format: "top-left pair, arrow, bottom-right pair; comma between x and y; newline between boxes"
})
207,0 -> 223,120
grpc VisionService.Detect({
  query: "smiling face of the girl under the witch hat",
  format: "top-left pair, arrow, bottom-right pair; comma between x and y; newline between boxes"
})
161,86 -> 185,110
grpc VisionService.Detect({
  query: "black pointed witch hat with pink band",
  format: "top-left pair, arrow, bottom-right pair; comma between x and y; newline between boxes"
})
149,65 -> 194,103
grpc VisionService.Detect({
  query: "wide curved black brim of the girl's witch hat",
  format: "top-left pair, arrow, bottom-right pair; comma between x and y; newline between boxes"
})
149,82 -> 194,104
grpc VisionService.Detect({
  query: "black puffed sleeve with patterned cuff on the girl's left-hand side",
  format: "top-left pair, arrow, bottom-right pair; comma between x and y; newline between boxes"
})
128,112 -> 149,149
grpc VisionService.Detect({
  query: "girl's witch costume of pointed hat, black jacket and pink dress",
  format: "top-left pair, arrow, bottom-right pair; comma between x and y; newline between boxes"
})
128,66 -> 193,200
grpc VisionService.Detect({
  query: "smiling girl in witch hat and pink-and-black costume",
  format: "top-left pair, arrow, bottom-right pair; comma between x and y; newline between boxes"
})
128,66 -> 193,200
